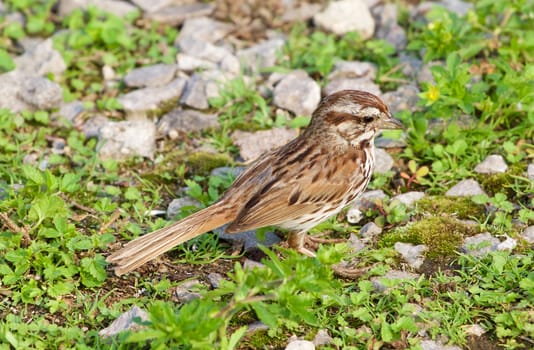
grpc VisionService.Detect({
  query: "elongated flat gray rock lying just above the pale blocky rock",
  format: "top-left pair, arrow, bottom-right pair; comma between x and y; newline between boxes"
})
118,77 -> 187,119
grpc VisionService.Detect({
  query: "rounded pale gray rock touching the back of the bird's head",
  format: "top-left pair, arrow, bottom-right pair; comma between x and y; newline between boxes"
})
273,71 -> 321,116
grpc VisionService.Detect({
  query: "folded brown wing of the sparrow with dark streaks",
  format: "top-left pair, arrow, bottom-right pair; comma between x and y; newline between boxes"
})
226,146 -> 366,233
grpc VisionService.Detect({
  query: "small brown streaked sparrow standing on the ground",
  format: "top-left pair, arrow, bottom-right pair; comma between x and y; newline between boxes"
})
107,90 -> 402,275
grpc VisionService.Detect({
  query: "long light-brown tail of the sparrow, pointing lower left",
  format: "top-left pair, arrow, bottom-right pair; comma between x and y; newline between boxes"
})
106,202 -> 235,276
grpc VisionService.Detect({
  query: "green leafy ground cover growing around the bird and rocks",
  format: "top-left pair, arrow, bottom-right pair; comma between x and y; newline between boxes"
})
0,0 -> 534,349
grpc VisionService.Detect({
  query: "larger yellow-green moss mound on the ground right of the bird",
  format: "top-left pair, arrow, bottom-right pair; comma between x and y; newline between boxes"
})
380,216 -> 479,258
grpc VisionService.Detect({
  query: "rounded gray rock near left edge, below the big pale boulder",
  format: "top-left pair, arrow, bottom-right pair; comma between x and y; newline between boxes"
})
19,77 -> 63,109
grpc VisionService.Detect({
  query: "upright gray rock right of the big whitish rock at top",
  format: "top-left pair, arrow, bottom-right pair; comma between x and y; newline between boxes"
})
373,4 -> 407,51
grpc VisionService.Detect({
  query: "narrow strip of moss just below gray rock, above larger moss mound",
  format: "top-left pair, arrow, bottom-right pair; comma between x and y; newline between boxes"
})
417,196 -> 485,219
